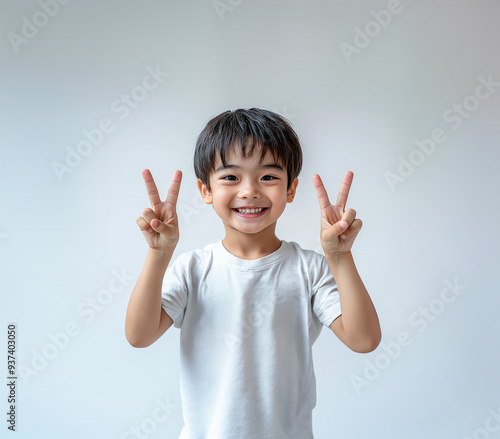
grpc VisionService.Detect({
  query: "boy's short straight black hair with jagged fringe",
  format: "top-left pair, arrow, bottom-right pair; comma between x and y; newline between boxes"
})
194,108 -> 302,191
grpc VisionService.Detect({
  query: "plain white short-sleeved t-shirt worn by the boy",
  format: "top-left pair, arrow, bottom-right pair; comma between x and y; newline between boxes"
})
162,240 -> 341,439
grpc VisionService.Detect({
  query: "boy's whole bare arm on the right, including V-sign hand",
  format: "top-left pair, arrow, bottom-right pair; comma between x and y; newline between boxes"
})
313,172 -> 382,353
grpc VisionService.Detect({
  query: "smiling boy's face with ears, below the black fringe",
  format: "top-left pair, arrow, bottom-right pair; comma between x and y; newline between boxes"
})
198,148 -> 299,239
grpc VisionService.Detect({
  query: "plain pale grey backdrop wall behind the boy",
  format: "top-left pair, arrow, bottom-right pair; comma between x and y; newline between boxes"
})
0,0 -> 500,439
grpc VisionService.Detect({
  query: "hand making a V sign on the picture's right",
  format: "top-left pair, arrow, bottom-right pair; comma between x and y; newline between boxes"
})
313,171 -> 363,256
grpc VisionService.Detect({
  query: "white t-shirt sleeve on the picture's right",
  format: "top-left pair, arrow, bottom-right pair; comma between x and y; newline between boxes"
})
311,253 -> 342,326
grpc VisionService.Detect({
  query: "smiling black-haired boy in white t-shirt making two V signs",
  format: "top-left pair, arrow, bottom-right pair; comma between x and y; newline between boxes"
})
125,108 -> 381,439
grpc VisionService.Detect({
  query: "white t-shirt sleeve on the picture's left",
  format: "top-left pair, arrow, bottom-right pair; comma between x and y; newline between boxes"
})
161,255 -> 188,328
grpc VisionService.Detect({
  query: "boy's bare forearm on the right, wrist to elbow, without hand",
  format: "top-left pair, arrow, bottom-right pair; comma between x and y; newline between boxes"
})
326,252 -> 381,347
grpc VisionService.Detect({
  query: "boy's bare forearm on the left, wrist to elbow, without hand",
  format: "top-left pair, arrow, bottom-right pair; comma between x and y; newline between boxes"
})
125,249 -> 174,347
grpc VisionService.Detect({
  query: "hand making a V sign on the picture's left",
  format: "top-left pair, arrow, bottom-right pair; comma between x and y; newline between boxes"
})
135,169 -> 182,251
